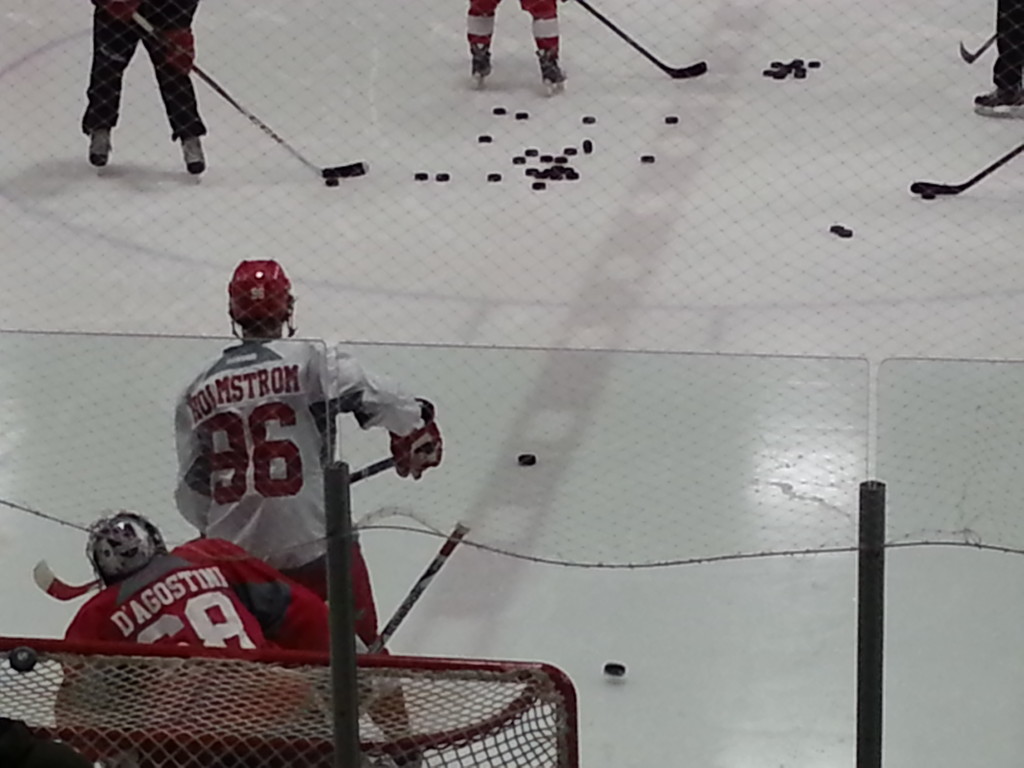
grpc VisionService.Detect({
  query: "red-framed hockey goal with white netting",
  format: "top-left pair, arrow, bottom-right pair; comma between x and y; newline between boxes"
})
0,638 -> 579,768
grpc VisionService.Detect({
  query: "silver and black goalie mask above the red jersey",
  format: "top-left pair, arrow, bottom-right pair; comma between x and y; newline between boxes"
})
85,511 -> 167,585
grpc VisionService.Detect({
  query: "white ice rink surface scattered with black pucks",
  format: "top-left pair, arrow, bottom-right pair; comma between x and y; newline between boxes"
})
0,0 -> 1024,768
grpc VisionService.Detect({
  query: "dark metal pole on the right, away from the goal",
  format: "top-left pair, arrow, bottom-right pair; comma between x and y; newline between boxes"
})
855,480 -> 886,768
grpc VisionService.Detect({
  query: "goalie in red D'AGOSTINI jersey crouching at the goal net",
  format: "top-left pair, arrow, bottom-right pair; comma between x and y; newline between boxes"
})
56,511 -> 420,768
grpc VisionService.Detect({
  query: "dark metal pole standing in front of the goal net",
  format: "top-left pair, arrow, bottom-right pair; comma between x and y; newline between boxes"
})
324,462 -> 359,768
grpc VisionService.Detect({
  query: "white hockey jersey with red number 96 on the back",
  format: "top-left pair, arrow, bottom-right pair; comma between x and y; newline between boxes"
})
175,339 -> 423,568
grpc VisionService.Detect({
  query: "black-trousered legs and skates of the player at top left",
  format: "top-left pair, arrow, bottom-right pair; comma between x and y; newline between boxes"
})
82,0 -> 206,175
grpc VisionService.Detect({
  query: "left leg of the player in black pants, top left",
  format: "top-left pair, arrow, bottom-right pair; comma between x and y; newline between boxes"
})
82,7 -> 139,166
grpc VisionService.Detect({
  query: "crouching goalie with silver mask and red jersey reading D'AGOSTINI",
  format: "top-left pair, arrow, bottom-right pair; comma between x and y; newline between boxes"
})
62,511 -> 420,768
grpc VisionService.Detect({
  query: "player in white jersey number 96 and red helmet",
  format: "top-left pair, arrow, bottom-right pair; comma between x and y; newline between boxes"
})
175,261 -> 442,645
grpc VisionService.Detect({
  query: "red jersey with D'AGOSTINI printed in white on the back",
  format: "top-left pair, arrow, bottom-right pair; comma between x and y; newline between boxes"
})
65,539 -> 329,652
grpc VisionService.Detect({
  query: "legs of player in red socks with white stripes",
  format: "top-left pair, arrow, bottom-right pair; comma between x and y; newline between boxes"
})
467,0 -> 565,94
